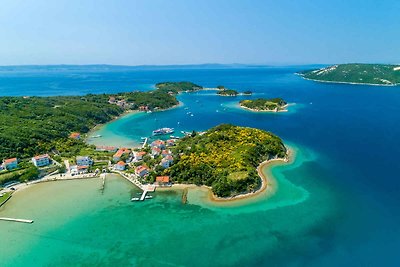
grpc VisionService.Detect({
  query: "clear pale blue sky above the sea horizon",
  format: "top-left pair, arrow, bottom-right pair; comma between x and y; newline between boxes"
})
0,0 -> 400,65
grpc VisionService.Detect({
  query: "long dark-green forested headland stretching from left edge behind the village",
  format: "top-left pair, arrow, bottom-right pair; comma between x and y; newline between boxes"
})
0,82 -> 202,160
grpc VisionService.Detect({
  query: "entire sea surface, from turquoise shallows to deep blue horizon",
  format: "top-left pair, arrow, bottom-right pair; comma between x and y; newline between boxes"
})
0,66 -> 400,266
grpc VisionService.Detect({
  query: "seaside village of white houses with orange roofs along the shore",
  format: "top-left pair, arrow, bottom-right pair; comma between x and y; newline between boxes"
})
0,132 -> 176,206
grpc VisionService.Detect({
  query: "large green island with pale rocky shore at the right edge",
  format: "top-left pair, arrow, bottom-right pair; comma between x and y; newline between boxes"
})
297,64 -> 400,86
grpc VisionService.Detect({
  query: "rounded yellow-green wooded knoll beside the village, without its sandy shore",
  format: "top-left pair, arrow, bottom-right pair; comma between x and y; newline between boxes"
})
165,124 -> 286,197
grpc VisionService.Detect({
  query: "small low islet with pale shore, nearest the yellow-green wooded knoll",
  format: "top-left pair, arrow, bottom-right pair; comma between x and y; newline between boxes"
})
239,98 -> 288,112
